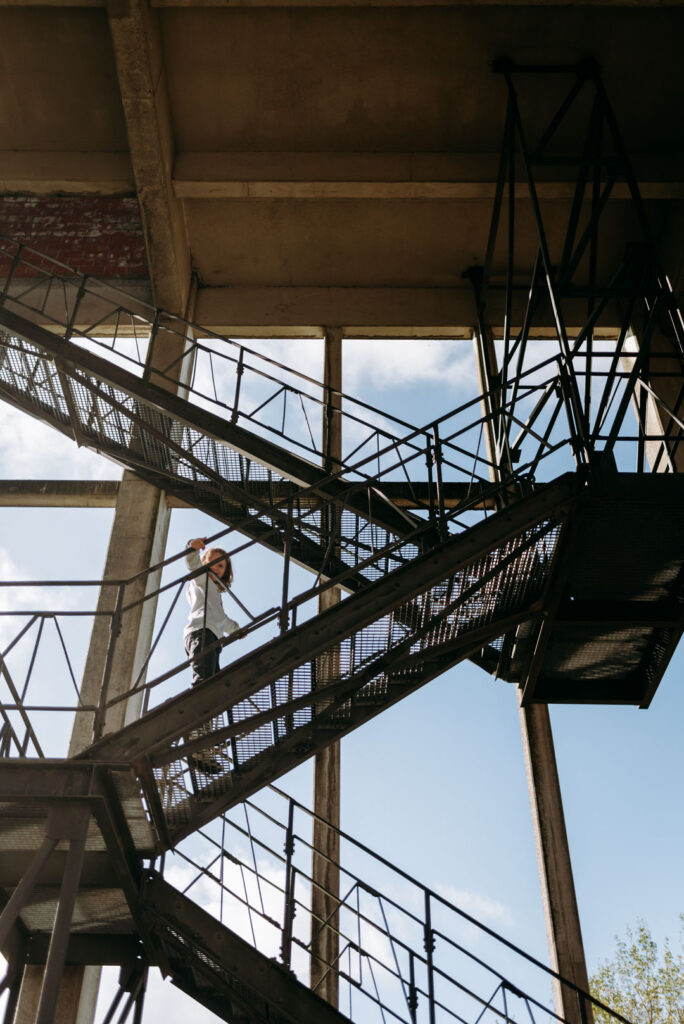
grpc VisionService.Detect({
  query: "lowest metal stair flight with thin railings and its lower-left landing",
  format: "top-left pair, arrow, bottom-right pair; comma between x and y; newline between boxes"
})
0,760 -> 628,1024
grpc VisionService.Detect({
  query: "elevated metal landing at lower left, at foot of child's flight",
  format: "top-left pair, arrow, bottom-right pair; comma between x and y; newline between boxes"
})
0,759 -> 153,964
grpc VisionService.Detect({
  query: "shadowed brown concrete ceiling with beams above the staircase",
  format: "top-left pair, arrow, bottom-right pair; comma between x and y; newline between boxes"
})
0,0 -> 684,333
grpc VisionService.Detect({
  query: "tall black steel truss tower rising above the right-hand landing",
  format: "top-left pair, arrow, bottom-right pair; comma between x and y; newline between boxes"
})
468,59 -> 684,475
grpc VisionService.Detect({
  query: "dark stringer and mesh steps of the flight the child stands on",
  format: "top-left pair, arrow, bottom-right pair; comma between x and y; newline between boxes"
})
80,474 -> 582,845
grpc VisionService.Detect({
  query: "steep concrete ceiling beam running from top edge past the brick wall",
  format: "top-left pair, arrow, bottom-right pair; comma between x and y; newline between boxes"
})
108,0 -> 190,315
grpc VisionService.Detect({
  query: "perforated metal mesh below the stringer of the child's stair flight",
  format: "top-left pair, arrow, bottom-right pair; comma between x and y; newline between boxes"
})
155,516 -> 563,829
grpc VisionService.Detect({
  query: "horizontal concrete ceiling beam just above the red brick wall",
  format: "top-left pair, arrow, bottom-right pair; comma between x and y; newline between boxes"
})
0,149 -> 684,201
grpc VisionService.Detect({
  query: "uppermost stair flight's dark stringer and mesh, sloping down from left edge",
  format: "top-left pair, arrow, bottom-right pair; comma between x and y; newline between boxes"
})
0,315 -> 425,590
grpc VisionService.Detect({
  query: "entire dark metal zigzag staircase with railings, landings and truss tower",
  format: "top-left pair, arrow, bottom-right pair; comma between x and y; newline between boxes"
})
0,61 -> 684,1024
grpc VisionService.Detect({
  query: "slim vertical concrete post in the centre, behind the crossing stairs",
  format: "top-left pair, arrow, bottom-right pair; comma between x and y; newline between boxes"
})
311,328 -> 342,1007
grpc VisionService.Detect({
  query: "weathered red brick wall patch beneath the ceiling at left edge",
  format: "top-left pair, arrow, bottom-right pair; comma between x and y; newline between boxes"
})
0,196 -> 147,279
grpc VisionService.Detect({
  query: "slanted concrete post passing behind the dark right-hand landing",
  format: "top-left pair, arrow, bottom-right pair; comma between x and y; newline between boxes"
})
473,335 -> 593,1024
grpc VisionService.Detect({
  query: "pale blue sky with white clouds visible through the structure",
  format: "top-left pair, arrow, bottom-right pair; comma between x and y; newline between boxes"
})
0,340 -> 684,1024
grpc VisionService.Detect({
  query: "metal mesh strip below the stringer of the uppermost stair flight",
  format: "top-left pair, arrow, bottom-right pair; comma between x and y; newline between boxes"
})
0,334 -> 419,582
